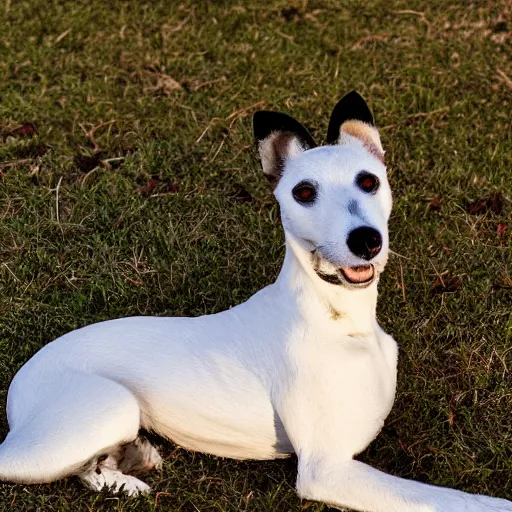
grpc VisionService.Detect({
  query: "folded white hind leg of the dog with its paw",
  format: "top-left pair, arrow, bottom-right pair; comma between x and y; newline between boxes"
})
0,369 -> 142,492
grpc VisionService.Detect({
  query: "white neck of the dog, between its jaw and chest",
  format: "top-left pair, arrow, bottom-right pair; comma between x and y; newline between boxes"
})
276,233 -> 377,334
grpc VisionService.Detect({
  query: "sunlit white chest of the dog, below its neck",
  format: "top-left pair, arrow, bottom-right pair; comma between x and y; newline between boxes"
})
288,335 -> 396,456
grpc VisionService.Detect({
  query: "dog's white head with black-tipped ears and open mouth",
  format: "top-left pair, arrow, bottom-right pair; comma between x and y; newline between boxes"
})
253,91 -> 391,288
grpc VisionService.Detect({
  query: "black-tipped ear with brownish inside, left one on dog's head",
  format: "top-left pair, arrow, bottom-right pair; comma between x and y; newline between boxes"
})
252,110 -> 316,186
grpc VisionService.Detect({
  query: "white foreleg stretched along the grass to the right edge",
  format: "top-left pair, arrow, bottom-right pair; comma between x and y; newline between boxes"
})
297,453 -> 512,512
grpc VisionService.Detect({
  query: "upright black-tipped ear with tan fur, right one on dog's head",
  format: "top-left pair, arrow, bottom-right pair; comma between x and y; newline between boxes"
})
327,91 -> 384,161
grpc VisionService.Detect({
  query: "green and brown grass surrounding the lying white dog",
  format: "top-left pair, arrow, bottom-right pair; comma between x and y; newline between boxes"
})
0,0 -> 512,512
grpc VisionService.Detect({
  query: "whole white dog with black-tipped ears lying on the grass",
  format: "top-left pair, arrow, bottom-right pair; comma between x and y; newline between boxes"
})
0,92 -> 512,512
